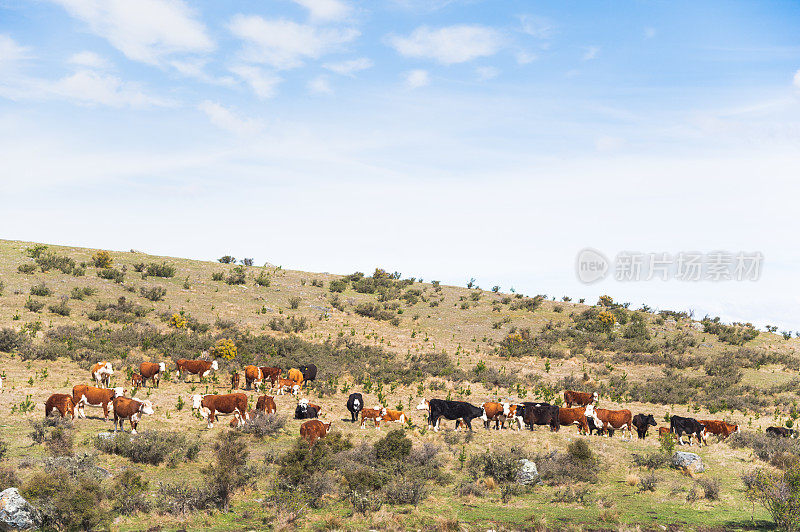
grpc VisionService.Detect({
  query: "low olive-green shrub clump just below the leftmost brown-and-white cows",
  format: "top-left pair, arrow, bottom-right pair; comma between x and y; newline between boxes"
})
94,430 -> 200,465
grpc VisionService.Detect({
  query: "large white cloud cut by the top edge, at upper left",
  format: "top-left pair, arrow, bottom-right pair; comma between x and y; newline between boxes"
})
51,0 -> 214,64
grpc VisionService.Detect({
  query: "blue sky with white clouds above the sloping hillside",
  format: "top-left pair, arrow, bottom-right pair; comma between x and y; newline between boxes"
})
0,0 -> 800,330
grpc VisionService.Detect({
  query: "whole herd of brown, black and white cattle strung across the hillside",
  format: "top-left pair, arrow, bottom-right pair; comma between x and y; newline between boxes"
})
39,359 -> 796,446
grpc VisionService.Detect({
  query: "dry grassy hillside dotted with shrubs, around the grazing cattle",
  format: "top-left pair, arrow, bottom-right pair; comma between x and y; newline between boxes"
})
0,241 -> 800,530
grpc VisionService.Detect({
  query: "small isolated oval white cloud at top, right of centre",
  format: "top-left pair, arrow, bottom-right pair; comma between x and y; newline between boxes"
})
389,25 -> 503,65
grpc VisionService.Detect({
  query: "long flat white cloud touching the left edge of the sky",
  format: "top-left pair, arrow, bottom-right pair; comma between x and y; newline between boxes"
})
0,70 -> 174,107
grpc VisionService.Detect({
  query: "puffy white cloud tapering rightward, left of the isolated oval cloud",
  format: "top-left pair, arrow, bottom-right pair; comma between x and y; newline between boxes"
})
229,15 -> 360,69
